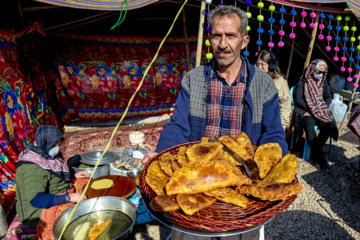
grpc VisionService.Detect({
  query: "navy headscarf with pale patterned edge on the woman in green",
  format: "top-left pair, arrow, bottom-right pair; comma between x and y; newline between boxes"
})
15,125 -> 70,181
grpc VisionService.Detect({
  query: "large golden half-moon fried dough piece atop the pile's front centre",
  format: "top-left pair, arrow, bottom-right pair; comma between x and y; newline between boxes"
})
166,161 -> 251,196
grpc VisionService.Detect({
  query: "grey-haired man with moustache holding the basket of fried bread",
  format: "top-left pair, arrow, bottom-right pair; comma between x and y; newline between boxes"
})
144,6 -> 288,240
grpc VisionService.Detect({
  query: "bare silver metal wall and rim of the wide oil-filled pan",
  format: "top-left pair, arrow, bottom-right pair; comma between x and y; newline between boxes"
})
52,196 -> 138,240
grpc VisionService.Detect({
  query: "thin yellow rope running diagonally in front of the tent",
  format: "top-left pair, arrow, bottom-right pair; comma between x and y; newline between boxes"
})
59,0 -> 188,237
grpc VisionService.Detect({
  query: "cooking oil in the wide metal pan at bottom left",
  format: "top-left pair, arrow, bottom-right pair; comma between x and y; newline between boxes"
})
62,210 -> 132,240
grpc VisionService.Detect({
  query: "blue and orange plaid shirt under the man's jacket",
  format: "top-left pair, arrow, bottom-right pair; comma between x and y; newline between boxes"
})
203,58 -> 249,138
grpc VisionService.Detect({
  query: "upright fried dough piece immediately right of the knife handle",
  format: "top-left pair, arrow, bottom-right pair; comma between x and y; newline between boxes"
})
254,143 -> 282,179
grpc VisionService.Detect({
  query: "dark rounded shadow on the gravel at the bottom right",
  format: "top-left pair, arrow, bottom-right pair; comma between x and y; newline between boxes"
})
265,210 -> 354,240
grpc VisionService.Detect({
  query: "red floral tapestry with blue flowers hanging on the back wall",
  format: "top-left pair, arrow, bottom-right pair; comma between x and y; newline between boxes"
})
51,34 -> 206,122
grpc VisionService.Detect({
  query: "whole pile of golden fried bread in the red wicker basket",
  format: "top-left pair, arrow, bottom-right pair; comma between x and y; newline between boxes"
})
145,132 -> 302,215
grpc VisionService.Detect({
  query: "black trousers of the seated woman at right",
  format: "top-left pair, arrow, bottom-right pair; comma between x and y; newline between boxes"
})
302,116 -> 332,157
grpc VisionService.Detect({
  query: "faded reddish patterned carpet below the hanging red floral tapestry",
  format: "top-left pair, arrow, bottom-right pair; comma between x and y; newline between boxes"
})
61,126 -> 163,161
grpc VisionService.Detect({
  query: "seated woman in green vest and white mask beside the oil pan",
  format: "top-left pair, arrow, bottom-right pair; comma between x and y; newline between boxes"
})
15,125 -> 90,239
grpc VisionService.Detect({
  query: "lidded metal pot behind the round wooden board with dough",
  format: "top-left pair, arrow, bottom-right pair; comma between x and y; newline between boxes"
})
68,150 -> 119,179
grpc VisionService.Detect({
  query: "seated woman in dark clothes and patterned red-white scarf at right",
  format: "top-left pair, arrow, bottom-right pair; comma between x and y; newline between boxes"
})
294,59 -> 338,169
